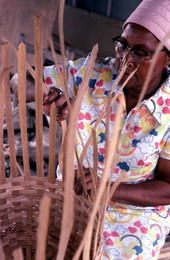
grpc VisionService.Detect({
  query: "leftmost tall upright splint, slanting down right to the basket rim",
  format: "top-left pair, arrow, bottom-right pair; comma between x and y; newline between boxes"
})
2,43 -> 18,177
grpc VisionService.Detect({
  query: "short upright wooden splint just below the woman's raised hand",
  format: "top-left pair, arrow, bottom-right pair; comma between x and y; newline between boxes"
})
48,103 -> 57,183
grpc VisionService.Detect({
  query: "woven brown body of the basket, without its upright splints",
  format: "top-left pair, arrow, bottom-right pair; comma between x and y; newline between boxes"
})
0,177 -> 100,260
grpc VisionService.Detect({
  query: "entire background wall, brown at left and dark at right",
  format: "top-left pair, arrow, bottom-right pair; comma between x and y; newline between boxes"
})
0,0 -> 141,70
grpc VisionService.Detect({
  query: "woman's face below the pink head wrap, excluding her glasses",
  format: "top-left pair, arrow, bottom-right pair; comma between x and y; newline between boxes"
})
115,23 -> 170,96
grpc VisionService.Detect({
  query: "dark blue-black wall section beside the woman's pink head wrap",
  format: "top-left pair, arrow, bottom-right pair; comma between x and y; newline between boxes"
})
54,0 -> 141,57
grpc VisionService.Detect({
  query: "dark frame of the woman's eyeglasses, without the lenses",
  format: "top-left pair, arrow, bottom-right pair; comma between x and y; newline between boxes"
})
112,35 -> 168,63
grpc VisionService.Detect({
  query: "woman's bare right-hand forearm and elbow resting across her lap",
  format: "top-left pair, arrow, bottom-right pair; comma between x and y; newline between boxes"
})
112,158 -> 170,206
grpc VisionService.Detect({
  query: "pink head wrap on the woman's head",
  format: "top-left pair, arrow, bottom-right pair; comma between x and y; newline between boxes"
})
123,0 -> 170,51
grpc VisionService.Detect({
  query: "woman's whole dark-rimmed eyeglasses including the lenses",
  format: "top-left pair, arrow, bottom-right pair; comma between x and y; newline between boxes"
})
112,36 -> 167,63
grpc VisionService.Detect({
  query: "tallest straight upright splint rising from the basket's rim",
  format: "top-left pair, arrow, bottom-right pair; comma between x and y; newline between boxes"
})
35,15 -> 44,176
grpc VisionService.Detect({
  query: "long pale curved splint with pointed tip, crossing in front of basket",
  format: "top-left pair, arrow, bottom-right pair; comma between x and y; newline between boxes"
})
57,45 -> 98,260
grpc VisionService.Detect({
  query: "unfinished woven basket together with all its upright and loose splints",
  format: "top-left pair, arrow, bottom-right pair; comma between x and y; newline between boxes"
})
0,0 -> 167,260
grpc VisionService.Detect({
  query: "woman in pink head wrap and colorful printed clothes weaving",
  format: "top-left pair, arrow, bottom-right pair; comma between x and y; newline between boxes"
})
34,0 -> 170,260
